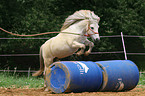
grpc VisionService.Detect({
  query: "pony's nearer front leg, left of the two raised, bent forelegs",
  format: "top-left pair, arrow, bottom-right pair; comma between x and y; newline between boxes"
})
72,41 -> 86,56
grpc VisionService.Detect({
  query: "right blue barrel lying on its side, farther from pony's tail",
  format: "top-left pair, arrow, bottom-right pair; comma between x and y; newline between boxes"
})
96,60 -> 139,91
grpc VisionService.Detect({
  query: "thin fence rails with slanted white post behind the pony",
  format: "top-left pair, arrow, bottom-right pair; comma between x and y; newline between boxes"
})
0,32 -> 145,73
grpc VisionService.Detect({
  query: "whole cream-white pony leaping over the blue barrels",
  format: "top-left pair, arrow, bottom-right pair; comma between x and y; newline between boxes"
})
33,10 -> 100,89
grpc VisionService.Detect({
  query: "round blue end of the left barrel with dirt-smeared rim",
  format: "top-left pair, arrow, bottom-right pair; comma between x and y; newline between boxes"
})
46,62 -> 70,93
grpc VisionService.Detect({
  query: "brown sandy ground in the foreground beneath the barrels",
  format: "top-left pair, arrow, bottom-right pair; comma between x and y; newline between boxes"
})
0,87 -> 145,96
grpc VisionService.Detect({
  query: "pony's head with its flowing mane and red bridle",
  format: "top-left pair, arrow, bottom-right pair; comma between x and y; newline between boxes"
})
61,10 -> 100,40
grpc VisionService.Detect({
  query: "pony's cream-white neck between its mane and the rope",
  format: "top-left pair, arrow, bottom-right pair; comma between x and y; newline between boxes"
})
62,20 -> 88,35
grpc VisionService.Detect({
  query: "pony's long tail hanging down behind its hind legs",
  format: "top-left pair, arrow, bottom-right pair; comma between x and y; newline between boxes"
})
32,46 -> 44,76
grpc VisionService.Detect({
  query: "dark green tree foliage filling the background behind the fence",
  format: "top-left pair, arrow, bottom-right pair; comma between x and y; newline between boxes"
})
0,0 -> 145,68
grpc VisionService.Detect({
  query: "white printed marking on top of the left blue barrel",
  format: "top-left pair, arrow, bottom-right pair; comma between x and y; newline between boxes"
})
75,62 -> 89,74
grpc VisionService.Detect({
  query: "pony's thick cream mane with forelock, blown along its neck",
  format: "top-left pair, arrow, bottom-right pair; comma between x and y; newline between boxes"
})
61,10 -> 100,31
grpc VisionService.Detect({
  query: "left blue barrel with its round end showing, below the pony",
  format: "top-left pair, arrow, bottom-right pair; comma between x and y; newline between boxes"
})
46,61 -> 103,93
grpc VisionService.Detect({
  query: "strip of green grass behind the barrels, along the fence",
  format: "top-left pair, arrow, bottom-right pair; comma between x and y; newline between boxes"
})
0,72 -> 145,88
